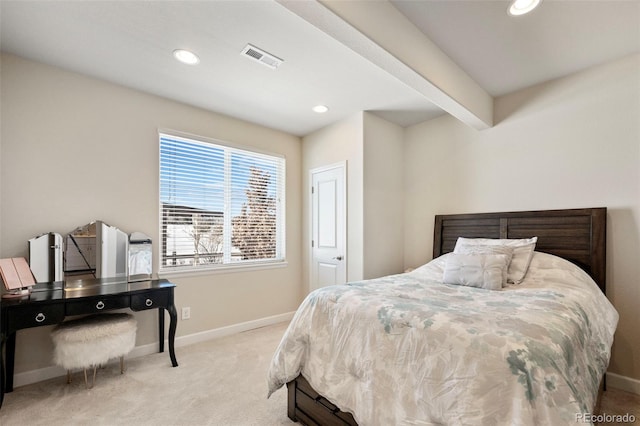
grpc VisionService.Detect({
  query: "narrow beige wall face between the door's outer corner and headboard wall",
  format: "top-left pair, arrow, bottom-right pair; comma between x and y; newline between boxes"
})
363,113 -> 404,278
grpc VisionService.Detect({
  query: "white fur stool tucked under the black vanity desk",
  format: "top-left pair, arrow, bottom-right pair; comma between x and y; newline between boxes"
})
51,313 -> 137,389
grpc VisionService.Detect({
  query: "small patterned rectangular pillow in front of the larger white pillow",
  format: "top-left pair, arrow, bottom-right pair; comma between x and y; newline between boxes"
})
442,253 -> 507,290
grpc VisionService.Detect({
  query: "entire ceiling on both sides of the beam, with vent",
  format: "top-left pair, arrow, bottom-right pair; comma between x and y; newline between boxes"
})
0,0 -> 640,136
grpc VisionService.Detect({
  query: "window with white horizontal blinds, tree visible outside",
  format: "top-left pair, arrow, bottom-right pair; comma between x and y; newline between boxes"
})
160,133 -> 285,272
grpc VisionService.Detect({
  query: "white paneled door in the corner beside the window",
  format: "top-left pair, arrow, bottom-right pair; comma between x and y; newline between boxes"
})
310,163 -> 347,290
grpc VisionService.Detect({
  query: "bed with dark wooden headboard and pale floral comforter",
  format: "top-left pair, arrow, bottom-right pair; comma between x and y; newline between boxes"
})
268,208 -> 618,425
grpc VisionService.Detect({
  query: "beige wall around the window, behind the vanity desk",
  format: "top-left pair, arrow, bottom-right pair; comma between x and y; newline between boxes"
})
0,54 -> 306,372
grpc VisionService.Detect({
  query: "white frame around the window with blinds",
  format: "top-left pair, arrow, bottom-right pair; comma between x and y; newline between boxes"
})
157,129 -> 287,275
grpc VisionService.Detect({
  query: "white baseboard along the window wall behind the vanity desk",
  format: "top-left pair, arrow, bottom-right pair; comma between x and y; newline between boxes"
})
13,312 -> 295,388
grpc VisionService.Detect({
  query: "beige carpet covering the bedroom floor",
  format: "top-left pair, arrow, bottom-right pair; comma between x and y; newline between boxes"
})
0,323 -> 640,426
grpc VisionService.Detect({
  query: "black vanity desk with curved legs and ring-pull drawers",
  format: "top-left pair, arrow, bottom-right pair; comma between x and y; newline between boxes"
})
0,278 -> 178,407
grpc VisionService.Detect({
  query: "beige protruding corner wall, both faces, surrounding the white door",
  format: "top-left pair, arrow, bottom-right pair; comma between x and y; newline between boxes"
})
302,112 -> 404,287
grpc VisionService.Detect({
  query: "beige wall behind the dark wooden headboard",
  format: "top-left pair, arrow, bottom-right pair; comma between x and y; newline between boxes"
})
405,55 -> 640,385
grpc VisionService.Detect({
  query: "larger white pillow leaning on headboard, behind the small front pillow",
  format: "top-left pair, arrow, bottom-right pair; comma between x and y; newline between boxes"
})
453,237 -> 538,284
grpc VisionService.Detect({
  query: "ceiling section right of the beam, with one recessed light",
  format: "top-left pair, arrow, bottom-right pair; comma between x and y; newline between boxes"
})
392,0 -> 640,96
